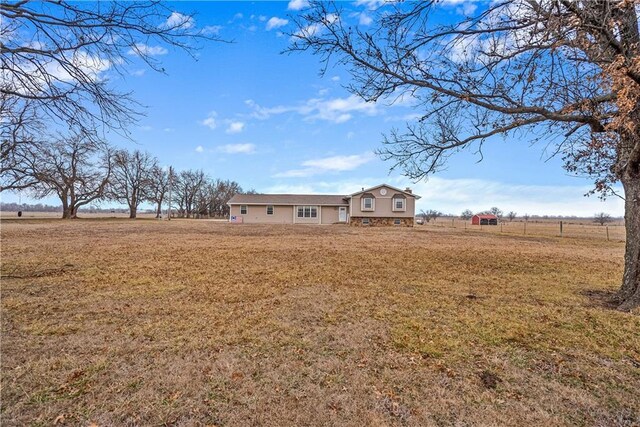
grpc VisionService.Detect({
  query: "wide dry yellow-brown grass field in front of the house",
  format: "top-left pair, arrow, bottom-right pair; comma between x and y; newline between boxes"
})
0,220 -> 640,426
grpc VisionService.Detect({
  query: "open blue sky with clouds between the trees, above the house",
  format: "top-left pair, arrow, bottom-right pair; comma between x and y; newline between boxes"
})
3,0 -> 624,216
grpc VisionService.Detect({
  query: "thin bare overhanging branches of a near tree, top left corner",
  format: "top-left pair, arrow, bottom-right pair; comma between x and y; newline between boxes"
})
0,0 -> 216,191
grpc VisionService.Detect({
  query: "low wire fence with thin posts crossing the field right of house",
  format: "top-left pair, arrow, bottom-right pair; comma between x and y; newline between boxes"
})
418,218 -> 626,242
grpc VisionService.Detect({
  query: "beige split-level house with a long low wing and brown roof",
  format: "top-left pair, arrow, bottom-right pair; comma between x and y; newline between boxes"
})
227,184 -> 420,227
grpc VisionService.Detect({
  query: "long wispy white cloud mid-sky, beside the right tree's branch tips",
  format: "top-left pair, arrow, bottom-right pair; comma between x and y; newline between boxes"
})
245,95 -> 379,123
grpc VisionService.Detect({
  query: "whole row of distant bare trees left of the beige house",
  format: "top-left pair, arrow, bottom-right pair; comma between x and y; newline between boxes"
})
1,135 -> 252,218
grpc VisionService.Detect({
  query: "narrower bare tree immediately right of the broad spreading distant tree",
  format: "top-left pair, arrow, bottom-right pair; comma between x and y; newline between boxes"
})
108,150 -> 157,219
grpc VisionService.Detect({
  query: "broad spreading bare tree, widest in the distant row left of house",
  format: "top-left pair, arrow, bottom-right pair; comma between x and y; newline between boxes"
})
27,135 -> 112,219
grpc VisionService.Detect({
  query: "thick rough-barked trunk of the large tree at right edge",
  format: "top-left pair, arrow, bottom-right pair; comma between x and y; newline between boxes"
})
618,171 -> 640,311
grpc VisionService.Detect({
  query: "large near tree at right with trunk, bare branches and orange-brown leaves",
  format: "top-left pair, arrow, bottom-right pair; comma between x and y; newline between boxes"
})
290,0 -> 640,310
